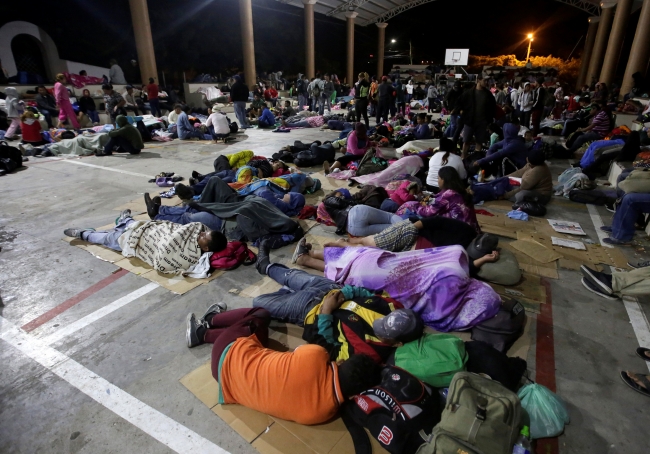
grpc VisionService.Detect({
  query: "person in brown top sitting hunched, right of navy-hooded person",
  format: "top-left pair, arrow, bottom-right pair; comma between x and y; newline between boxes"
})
503,150 -> 553,205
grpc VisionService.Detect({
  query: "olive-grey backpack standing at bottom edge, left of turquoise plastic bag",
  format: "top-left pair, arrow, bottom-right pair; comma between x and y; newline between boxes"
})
417,372 -> 521,454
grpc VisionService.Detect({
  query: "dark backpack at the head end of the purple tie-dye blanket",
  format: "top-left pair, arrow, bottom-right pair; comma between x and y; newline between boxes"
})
472,298 -> 526,353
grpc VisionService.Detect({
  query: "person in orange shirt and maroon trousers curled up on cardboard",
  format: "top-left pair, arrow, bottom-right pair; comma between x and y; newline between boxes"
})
186,303 -> 381,424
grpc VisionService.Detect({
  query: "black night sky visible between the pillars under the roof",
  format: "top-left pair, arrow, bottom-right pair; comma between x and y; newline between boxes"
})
2,0 -> 638,83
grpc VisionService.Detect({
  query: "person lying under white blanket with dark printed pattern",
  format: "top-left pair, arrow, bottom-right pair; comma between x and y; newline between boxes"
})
63,210 -> 227,274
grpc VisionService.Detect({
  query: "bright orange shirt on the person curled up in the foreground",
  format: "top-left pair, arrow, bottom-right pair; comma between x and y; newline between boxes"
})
220,335 -> 343,424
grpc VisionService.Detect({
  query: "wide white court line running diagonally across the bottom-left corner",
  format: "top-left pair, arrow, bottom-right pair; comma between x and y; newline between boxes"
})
0,316 -> 229,454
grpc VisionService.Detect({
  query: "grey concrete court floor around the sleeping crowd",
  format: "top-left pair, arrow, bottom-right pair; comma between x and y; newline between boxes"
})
0,119 -> 650,454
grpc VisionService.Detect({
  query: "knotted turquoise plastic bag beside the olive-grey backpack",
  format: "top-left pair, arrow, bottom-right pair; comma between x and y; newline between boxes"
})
518,383 -> 570,439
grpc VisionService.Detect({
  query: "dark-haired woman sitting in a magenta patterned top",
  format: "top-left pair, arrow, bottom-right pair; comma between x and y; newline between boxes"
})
393,166 -> 481,233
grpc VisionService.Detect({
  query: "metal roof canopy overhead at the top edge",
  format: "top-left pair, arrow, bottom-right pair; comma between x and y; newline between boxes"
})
278,0 -> 600,25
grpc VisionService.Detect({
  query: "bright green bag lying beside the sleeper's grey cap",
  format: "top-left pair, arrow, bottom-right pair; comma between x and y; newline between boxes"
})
395,333 -> 467,388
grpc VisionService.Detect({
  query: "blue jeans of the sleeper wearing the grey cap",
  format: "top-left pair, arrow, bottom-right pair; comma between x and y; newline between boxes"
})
253,263 -> 341,326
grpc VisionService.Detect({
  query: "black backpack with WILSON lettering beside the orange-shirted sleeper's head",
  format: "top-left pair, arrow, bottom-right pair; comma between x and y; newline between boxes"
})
341,366 -> 441,454
